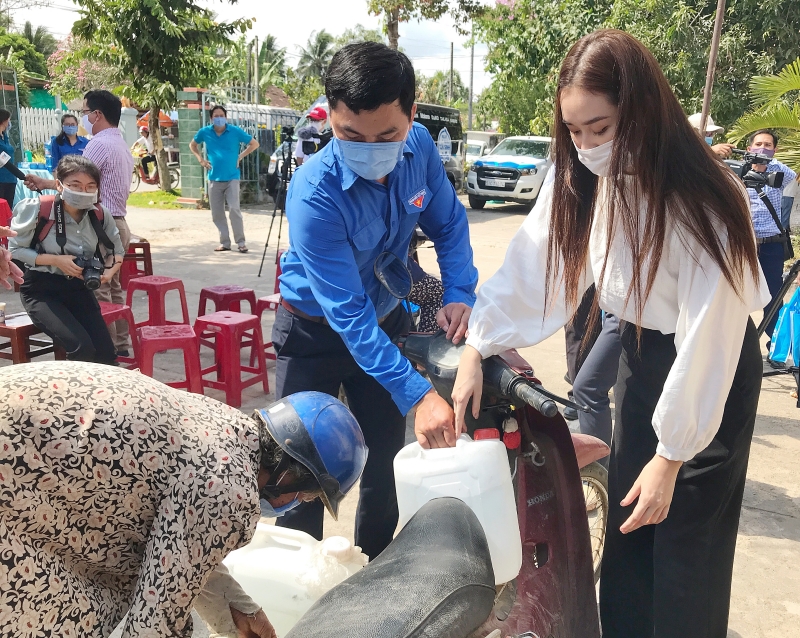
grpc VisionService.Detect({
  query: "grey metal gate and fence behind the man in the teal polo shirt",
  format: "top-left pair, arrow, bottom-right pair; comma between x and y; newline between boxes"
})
201,87 -> 300,202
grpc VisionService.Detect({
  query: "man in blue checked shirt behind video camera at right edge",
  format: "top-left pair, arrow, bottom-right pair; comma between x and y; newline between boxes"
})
747,129 -> 797,351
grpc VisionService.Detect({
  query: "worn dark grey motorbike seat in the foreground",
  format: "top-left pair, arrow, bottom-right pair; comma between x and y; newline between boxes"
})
286,498 -> 495,638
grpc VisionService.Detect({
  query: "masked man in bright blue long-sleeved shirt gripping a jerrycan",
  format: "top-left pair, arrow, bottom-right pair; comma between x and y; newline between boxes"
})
272,42 -> 478,558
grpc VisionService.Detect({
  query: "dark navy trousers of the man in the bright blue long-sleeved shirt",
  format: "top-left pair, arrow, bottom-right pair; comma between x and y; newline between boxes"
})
272,306 -> 409,559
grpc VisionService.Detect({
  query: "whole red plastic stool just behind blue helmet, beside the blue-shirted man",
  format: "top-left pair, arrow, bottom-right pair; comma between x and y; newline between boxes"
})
194,310 -> 269,408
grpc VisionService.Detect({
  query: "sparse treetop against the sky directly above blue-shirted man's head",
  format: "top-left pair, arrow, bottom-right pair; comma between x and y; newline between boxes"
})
367,0 -> 486,49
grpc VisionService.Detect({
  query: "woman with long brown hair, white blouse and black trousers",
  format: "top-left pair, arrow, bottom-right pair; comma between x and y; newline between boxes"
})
453,30 -> 768,638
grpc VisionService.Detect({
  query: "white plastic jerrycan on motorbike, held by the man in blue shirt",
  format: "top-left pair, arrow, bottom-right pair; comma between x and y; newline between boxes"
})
394,434 -> 522,584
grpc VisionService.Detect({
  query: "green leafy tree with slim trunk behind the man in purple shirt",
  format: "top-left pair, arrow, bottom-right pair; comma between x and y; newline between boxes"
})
68,0 -> 252,190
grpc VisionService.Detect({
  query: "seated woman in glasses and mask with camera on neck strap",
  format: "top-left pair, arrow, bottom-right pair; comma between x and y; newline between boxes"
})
9,155 -> 124,364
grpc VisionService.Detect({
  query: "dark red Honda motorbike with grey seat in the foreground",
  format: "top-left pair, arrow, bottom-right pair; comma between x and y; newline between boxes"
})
286,332 -> 609,638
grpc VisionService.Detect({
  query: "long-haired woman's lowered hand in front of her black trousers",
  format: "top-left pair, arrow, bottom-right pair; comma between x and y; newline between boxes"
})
619,454 -> 683,534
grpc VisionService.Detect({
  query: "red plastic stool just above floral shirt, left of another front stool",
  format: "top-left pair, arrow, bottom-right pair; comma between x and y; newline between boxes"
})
137,324 -> 203,394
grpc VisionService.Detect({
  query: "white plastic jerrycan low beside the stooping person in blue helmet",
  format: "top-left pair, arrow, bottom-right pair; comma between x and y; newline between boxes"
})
223,523 -> 368,638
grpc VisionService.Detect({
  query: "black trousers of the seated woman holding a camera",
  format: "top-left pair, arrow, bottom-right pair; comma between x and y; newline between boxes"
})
20,270 -> 117,364
